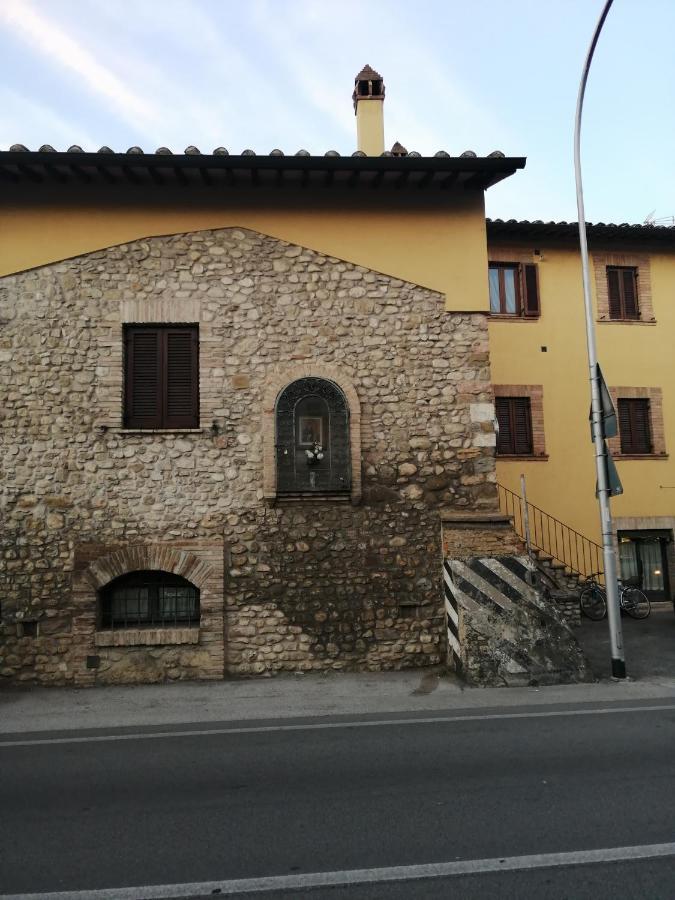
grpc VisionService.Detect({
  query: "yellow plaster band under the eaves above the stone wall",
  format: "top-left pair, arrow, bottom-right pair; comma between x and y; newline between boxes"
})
0,191 -> 488,310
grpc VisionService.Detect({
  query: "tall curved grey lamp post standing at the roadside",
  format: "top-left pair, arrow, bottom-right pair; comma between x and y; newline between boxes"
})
574,0 -> 626,678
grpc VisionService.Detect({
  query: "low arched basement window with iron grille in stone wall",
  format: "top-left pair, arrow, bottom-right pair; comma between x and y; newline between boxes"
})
99,571 -> 199,628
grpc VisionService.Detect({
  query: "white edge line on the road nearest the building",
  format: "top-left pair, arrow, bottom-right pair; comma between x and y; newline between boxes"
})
0,703 -> 675,748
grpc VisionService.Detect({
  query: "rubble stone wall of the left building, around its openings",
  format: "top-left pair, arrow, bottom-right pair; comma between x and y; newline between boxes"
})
0,228 -> 497,685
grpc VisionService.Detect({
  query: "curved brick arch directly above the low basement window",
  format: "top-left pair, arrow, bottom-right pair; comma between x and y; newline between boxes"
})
84,544 -> 214,591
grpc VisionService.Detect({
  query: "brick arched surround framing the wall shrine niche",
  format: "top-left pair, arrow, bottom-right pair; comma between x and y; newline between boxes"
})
262,362 -> 362,503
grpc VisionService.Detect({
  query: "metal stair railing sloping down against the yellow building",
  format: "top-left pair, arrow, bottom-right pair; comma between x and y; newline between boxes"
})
497,484 -> 604,581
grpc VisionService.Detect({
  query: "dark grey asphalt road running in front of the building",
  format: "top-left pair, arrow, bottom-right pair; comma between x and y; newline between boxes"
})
0,699 -> 675,900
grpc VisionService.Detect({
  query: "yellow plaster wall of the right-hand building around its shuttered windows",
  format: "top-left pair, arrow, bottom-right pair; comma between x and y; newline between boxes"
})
489,243 -> 675,541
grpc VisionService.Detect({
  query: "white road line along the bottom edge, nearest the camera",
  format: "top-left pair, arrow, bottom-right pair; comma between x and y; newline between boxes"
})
0,843 -> 675,900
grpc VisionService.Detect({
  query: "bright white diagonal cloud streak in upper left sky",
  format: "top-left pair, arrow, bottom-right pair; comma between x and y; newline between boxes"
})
0,0 -> 156,133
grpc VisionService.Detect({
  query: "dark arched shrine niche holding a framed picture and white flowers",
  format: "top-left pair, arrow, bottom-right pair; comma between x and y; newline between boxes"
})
276,378 -> 351,494
